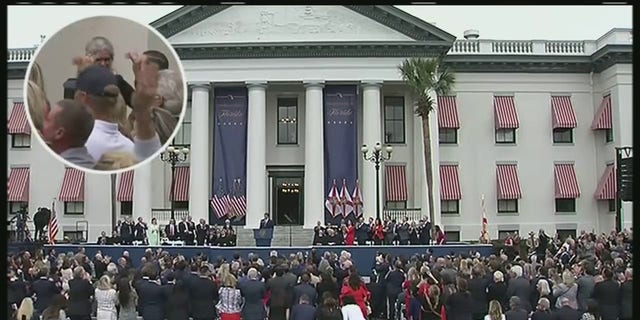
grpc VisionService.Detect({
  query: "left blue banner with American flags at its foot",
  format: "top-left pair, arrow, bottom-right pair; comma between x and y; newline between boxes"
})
212,87 -> 249,225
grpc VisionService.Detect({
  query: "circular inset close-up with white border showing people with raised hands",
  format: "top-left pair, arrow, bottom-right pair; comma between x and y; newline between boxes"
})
24,16 -> 187,174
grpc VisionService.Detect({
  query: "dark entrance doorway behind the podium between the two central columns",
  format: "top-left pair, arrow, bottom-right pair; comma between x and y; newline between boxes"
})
271,176 -> 304,226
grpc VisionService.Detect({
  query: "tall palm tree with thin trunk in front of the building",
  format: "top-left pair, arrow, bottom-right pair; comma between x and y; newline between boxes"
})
398,56 -> 455,223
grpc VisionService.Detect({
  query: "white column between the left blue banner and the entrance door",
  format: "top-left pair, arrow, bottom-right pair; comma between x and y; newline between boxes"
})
245,81 -> 268,229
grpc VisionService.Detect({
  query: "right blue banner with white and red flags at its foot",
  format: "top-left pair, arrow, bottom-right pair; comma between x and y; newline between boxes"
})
323,85 -> 360,225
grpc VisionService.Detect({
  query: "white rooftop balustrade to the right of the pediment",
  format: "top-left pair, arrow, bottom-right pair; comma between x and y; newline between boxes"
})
449,29 -> 633,56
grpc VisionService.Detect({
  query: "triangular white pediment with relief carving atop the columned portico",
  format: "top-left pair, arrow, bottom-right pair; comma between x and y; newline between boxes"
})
151,5 -> 455,45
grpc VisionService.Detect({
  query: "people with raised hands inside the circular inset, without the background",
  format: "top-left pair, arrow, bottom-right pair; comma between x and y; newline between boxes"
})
27,36 -> 184,170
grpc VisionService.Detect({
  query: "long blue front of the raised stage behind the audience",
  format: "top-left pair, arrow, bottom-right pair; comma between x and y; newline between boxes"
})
44,243 -> 494,276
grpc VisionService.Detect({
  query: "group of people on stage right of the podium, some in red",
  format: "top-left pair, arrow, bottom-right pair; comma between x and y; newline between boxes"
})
313,216 -> 447,246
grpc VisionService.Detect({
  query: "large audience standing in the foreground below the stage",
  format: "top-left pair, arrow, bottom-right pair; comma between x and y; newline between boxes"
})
7,226 -> 633,320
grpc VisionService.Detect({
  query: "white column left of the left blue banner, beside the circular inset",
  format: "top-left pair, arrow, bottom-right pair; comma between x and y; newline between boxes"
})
188,82 -> 211,223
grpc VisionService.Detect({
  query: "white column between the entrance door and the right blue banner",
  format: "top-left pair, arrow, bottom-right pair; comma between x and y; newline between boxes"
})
304,81 -> 325,228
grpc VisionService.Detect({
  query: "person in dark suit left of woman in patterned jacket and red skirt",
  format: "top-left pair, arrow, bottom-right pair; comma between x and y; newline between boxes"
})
189,266 -> 219,320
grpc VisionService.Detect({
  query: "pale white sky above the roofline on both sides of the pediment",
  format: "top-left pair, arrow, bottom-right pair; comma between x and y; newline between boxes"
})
7,5 -> 632,48
